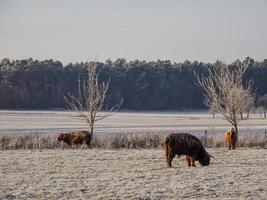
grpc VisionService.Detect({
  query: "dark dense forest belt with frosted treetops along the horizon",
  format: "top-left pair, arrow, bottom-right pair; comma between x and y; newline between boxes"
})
0,57 -> 267,110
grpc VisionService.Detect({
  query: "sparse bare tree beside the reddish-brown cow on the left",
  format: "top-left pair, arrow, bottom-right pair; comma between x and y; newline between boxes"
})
64,65 -> 123,138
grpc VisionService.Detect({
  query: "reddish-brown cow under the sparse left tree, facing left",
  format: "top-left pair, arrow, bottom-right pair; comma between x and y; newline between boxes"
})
58,131 -> 92,148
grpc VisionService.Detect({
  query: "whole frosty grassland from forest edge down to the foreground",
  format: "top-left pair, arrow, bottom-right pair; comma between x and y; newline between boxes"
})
0,111 -> 267,199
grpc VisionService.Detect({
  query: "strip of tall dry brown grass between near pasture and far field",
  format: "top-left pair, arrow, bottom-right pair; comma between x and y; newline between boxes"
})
0,133 -> 267,150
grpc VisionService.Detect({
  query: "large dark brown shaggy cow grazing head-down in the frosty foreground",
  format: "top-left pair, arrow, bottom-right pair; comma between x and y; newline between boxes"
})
165,133 -> 212,167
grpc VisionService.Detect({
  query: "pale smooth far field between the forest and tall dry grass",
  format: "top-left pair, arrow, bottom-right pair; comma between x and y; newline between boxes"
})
0,110 -> 267,135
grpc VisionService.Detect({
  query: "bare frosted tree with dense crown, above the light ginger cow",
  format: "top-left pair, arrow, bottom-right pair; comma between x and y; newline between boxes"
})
197,62 -> 255,139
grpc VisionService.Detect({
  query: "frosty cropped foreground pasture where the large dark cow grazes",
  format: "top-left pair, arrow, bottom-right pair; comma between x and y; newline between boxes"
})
0,148 -> 267,199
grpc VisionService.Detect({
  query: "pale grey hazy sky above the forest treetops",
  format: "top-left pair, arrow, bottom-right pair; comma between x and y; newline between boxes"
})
0,0 -> 267,64
